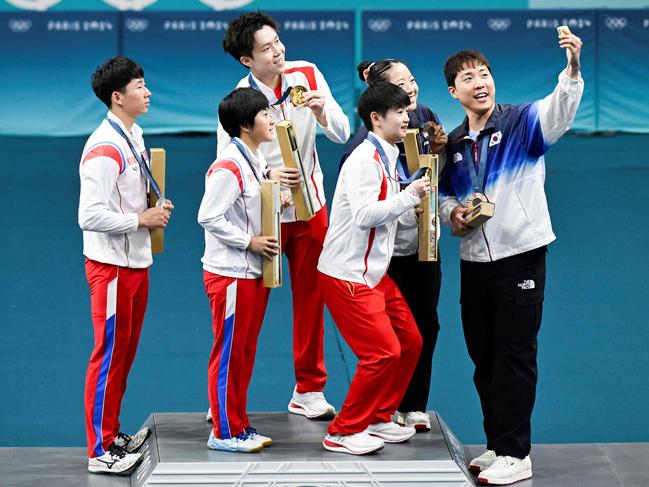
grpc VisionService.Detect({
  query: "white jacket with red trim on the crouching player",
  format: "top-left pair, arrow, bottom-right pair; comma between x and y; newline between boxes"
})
318,134 -> 420,288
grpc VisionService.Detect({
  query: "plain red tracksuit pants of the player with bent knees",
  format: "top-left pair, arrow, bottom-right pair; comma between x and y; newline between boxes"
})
319,273 -> 422,435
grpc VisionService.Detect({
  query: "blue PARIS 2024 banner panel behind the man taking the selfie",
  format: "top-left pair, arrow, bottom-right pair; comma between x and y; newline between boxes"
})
362,10 -> 596,131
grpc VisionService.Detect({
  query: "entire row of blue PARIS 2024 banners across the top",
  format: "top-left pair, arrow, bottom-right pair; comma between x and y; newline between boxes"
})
0,10 -> 649,136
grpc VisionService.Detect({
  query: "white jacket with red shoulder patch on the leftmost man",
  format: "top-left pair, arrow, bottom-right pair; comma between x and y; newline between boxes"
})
78,112 -> 153,269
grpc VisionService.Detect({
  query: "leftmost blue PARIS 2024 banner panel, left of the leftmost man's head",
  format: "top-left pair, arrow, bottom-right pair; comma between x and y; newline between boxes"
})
0,12 -> 119,136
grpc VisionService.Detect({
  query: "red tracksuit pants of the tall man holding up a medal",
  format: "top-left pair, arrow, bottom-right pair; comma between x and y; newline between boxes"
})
282,206 -> 327,393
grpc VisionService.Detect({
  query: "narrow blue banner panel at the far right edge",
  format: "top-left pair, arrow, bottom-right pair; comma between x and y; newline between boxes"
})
597,10 -> 649,133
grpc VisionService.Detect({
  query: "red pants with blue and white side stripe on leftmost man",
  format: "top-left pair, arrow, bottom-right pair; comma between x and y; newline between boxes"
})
85,259 -> 149,458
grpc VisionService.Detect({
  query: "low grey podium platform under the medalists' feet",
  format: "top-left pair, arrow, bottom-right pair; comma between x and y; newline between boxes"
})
130,412 -> 475,487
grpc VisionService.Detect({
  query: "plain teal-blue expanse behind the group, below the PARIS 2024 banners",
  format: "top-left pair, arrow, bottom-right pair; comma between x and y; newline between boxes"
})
0,135 -> 649,446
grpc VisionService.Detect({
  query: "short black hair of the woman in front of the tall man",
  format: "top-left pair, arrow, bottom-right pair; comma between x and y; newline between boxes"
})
219,88 -> 268,137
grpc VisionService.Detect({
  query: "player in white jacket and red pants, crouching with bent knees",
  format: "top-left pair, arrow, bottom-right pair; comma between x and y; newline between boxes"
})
318,82 -> 430,455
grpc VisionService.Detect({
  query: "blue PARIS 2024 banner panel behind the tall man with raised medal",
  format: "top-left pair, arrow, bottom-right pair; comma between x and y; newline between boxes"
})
122,11 -> 354,133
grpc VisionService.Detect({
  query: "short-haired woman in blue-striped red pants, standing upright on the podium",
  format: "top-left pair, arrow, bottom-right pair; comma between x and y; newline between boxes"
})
198,88 -> 288,452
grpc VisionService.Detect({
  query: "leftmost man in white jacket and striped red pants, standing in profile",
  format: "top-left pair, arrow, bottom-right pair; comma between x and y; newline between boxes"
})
79,57 -> 173,474
